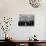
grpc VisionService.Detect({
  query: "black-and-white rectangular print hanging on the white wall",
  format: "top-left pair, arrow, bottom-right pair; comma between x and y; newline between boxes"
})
18,15 -> 34,26
